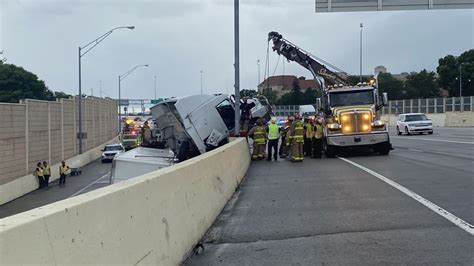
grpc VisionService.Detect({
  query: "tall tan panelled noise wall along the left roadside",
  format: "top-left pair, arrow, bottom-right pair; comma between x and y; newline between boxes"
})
0,97 -> 118,188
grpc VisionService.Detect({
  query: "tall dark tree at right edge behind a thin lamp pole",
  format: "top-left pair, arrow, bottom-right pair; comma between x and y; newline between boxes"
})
436,49 -> 474,96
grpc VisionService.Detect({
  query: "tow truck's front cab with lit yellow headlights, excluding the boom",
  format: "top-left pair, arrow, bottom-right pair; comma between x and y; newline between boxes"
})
316,86 -> 391,157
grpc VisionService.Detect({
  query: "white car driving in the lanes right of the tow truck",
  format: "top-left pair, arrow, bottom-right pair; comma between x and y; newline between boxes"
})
397,113 -> 433,135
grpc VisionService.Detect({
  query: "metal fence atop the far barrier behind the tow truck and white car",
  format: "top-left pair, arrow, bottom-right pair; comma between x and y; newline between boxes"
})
273,96 -> 474,116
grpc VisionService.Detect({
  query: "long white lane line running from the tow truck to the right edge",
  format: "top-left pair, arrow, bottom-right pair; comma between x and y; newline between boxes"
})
338,157 -> 474,236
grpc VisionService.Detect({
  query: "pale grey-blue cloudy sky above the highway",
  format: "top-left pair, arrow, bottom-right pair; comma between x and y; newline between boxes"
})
0,0 -> 474,99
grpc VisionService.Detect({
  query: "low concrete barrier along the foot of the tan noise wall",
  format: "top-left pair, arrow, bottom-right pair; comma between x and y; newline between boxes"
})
0,137 -> 118,205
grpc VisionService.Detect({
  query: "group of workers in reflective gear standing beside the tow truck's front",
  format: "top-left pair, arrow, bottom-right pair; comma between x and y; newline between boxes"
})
248,114 -> 324,162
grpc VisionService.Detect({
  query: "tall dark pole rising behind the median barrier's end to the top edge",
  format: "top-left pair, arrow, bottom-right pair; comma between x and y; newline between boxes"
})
234,0 -> 240,136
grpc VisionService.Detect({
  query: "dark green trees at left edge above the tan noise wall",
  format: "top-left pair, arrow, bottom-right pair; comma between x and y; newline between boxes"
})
0,64 -> 54,103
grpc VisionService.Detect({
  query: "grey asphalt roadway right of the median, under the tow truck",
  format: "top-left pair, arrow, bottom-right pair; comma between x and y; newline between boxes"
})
186,128 -> 474,265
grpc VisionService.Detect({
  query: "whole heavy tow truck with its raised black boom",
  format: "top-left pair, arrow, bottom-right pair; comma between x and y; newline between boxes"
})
268,31 -> 392,158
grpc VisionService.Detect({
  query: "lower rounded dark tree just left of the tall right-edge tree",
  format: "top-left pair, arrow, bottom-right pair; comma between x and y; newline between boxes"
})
405,69 -> 438,98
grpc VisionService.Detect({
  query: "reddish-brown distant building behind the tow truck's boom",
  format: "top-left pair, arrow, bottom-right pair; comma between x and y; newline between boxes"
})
257,75 -> 319,98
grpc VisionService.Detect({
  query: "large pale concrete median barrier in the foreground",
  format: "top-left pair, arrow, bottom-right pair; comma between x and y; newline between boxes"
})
0,139 -> 250,265
